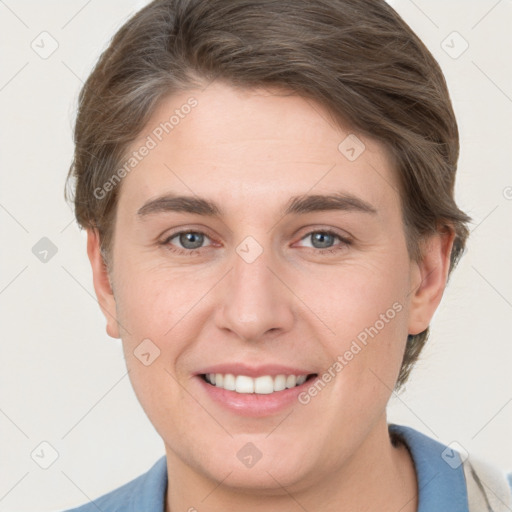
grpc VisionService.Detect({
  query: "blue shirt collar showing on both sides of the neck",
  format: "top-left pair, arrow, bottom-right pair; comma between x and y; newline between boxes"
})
61,423 -> 512,512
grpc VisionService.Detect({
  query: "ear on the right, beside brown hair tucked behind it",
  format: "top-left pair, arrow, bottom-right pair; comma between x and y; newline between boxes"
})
409,226 -> 455,334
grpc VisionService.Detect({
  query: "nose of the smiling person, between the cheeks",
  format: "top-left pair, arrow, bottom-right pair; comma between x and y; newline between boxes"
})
216,241 -> 296,341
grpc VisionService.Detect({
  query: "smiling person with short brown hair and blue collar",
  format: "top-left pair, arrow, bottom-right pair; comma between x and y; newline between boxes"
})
61,0 -> 511,512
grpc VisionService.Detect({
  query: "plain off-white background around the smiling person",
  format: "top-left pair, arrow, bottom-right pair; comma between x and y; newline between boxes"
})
0,0 -> 512,512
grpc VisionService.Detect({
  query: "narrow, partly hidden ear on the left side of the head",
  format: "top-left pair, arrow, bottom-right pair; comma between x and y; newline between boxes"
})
87,229 -> 120,338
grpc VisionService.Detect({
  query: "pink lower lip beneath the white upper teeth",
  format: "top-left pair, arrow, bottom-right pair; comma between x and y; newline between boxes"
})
196,375 -> 318,417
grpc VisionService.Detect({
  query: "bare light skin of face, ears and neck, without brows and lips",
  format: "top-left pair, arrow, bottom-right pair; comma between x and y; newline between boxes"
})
88,82 -> 454,512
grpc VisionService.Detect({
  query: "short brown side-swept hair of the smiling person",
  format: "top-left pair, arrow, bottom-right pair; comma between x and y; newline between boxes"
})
65,0 -> 472,389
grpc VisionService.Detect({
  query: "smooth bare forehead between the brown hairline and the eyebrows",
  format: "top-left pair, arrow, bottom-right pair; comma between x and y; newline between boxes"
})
119,82 -> 399,220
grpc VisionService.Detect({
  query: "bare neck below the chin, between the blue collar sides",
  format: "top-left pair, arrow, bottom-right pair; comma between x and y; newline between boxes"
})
165,413 -> 418,512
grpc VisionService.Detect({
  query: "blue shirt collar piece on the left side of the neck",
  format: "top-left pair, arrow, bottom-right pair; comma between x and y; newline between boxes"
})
58,456 -> 167,512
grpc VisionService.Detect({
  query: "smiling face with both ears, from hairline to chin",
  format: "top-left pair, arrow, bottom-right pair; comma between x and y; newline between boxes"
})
89,82 -> 450,488
